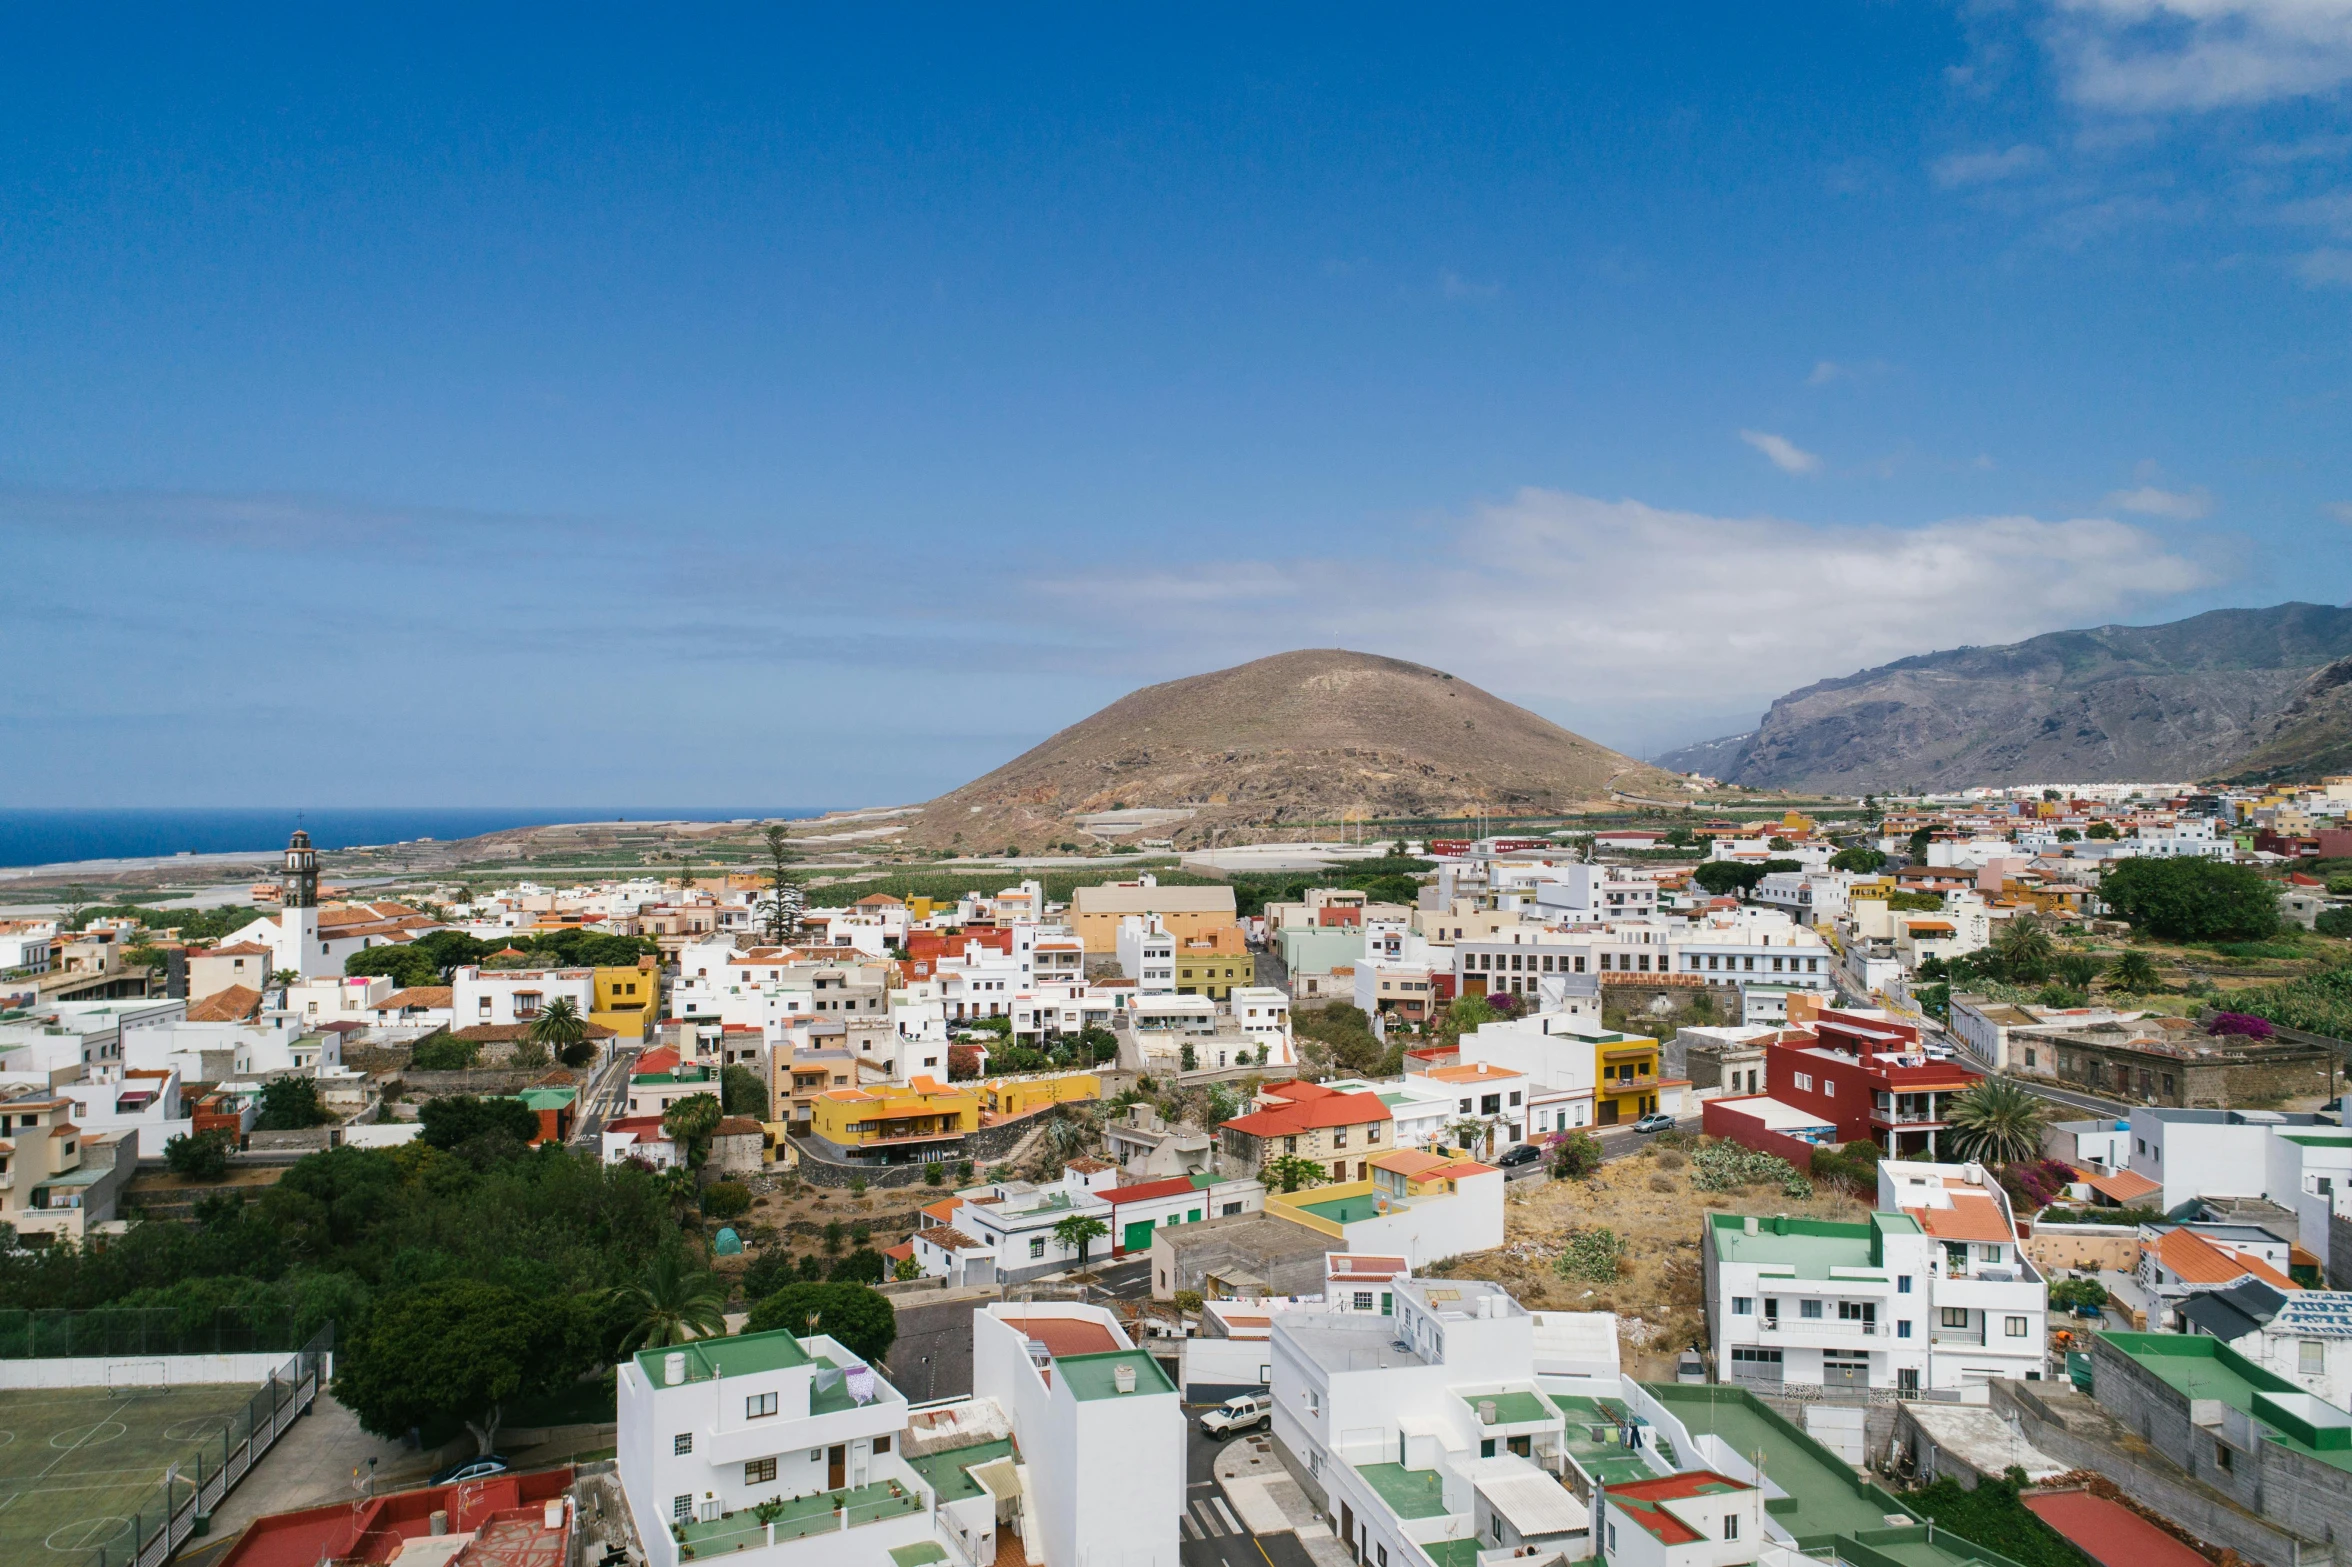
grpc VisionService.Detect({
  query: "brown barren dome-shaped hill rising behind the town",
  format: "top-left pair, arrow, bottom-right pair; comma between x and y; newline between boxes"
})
910,647 -> 1679,849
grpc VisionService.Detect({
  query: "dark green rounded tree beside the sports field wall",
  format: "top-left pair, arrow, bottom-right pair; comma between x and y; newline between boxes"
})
334,1278 -> 576,1452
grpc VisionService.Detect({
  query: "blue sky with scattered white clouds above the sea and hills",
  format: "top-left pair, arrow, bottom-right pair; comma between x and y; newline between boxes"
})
0,0 -> 2352,805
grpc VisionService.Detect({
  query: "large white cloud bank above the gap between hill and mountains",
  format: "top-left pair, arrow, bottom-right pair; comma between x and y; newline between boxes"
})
1047,489 -> 2211,729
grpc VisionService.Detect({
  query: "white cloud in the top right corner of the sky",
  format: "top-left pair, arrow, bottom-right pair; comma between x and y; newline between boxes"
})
2051,0 -> 2352,113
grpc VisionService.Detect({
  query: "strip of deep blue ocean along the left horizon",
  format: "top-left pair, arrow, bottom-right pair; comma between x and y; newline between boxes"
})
0,805 -> 833,866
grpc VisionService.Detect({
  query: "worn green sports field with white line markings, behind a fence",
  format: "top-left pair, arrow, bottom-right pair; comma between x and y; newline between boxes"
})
0,1383 -> 256,1567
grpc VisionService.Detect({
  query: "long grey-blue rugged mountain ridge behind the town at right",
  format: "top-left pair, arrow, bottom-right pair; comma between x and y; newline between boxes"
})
1661,605 -> 2352,793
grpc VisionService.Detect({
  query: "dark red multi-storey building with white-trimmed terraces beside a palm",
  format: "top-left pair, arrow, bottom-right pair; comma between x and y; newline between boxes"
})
1764,1007 -> 1983,1158
